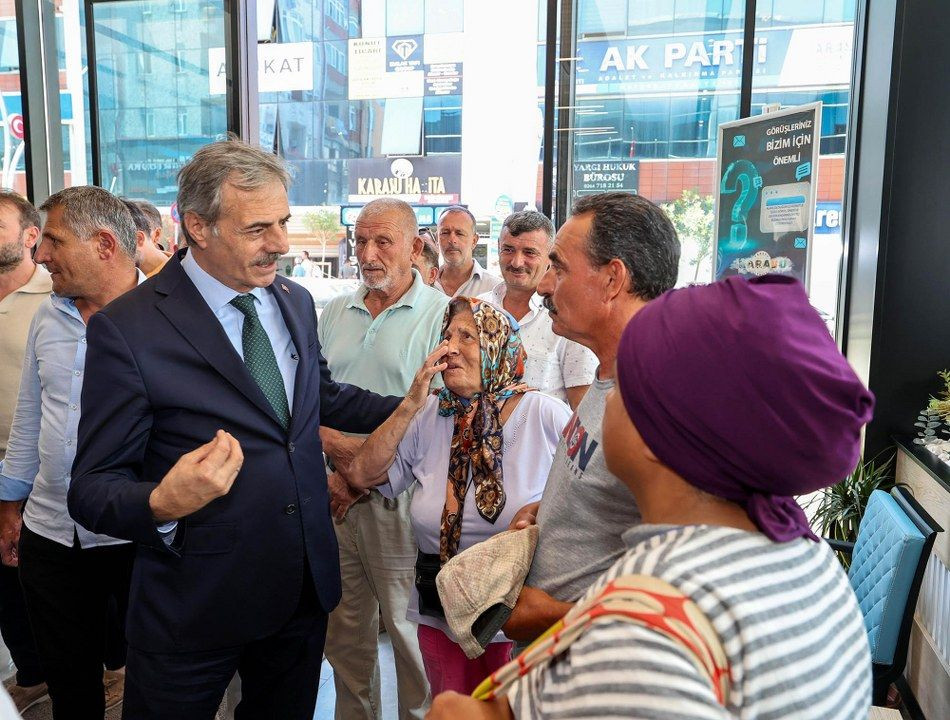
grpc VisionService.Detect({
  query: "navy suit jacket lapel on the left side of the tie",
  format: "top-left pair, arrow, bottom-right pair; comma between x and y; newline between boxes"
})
155,256 -> 280,427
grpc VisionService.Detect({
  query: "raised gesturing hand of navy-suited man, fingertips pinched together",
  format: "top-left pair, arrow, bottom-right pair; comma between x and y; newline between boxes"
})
148,430 -> 244,523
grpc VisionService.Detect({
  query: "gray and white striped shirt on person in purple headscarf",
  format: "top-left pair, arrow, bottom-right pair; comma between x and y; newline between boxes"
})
508,525 -> 871,720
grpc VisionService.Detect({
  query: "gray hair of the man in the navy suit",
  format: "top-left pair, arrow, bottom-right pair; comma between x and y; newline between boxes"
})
178,138 -> 290,245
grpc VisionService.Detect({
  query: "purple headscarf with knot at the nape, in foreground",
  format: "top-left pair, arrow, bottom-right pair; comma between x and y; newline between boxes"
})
617,275 -> 874,542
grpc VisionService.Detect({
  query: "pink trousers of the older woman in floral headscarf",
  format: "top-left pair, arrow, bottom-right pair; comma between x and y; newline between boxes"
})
419,625 -> 514,697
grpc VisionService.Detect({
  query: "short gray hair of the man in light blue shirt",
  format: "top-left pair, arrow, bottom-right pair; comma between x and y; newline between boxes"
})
39,185 -> 136,259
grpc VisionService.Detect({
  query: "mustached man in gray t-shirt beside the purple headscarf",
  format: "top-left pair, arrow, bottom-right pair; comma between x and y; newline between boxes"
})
504,192 -> 680,641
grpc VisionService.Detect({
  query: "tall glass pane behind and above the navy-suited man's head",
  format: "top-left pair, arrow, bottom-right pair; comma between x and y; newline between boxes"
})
87,0 -> 231,208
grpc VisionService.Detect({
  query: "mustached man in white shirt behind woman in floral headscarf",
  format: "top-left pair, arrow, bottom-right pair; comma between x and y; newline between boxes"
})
479,210 -> 597,410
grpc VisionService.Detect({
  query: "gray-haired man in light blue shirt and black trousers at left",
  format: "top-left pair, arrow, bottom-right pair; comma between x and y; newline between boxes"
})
0,187 -> 140,720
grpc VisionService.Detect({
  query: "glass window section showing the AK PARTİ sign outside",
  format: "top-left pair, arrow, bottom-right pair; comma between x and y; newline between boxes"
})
558,0 -> 855,324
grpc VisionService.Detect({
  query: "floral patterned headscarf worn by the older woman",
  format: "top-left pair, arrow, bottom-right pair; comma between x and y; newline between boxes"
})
435,297 -> 530,565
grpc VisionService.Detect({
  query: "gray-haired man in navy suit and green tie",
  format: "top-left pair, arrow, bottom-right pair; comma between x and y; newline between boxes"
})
69,141 -> 398,720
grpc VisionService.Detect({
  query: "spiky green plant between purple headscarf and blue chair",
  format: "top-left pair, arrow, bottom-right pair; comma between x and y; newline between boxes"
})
806,448 -> 897,568
